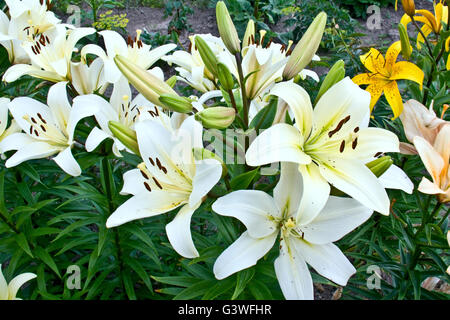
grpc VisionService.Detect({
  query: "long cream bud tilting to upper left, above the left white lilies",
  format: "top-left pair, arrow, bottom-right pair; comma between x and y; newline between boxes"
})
114,55 -> 178,107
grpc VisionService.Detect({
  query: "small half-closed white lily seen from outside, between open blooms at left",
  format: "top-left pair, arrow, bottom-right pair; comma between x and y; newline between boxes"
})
70,58 -> 108,95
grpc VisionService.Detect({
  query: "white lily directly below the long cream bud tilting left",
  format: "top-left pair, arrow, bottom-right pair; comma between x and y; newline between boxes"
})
82,73 -> 162,157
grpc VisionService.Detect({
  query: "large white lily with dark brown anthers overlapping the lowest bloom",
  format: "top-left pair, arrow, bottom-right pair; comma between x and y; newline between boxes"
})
246,77 -> 399,215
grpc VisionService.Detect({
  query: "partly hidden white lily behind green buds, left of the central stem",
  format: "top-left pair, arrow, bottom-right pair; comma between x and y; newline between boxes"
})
162,34 -> 231,93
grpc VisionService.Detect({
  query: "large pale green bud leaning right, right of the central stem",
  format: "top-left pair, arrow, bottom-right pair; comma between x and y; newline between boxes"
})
283,12 -> 327,80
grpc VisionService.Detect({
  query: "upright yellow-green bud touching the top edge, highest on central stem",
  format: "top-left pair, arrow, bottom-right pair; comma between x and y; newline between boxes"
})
216,1 -> 241,54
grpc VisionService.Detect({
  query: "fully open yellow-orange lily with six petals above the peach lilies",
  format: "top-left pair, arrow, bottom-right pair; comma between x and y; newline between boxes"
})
352,41 -> 424,119
